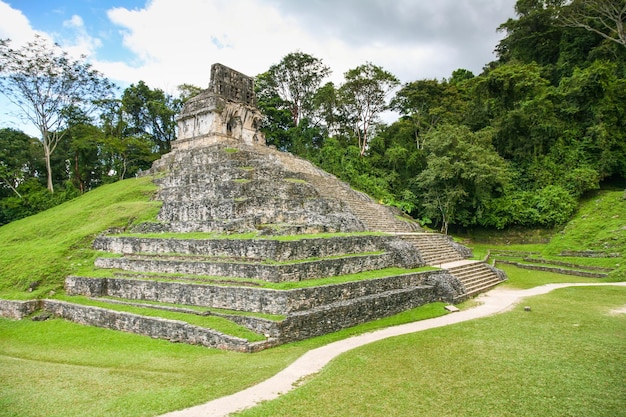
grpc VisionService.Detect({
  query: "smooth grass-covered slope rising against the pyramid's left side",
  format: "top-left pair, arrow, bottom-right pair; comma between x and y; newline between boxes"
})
0,177 -> 160,299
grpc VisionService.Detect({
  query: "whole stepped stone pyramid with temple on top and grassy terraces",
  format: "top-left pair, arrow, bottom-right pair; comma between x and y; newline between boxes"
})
0,64 -> 506,352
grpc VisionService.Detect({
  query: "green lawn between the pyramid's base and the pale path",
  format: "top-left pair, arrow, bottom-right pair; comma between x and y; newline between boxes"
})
0,303 -> 445,417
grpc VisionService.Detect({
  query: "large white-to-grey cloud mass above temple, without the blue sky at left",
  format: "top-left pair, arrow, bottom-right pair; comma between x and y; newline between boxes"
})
97,0 -> 514,91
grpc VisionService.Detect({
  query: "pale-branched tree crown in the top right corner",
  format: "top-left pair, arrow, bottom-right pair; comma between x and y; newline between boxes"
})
561,0 -> 626,47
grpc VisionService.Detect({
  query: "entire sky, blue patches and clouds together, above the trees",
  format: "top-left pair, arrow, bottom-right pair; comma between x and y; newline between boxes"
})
0,0 -> 515,131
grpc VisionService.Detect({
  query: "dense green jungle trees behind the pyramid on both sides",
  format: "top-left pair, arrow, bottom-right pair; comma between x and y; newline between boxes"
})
0,0 -> 626,232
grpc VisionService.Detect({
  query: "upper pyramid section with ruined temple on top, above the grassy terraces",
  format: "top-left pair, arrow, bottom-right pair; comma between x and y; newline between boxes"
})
146,64 -> 420,234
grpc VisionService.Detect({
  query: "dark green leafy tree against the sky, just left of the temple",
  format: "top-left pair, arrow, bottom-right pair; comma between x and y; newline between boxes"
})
122,81 -> 182,155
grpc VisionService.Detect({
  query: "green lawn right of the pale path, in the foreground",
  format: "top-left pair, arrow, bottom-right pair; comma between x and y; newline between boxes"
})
237,287 -> 626,417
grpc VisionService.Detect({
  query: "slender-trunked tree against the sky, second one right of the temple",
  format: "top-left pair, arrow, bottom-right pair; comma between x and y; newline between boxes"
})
339,62 -> 400,156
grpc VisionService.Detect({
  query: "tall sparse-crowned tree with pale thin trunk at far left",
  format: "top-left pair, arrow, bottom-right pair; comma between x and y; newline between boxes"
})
0,36 -> 113,192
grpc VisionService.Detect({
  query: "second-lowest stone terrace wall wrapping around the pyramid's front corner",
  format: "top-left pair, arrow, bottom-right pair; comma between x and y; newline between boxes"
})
65,271 -> 454,315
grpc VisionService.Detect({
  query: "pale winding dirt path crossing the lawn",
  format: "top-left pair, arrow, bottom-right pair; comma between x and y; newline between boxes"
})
163,282 -> 626,417
